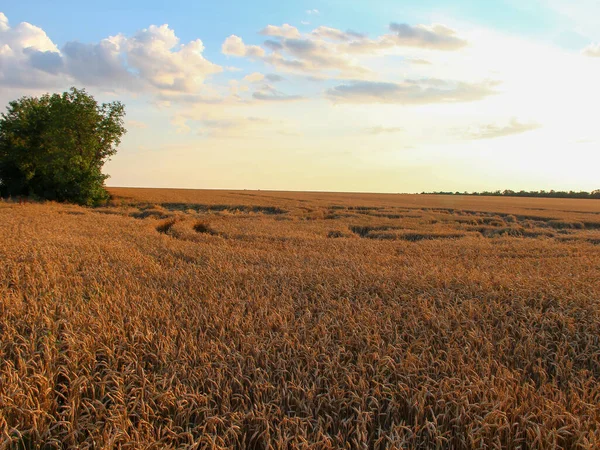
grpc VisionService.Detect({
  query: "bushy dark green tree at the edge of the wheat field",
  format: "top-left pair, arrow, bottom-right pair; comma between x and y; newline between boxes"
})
0,87 -> 125,205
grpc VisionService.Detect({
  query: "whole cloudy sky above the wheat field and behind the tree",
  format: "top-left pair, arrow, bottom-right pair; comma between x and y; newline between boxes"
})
0,0 -> 600,192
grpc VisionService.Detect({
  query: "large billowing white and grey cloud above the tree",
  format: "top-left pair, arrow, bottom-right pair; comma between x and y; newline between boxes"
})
0,13 -> 222,92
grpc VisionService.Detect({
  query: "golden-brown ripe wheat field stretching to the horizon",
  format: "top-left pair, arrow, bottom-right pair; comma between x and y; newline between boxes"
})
0,188 -> 600,449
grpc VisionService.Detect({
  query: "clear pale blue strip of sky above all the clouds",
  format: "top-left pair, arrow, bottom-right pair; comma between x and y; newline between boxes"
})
2,0 -> 577,47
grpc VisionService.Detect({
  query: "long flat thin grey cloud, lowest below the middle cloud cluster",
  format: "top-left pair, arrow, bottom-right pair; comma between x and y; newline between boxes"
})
326,79 -> 496,104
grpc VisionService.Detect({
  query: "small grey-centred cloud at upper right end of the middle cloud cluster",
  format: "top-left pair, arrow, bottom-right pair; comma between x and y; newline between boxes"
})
390,23 -> 467,50
